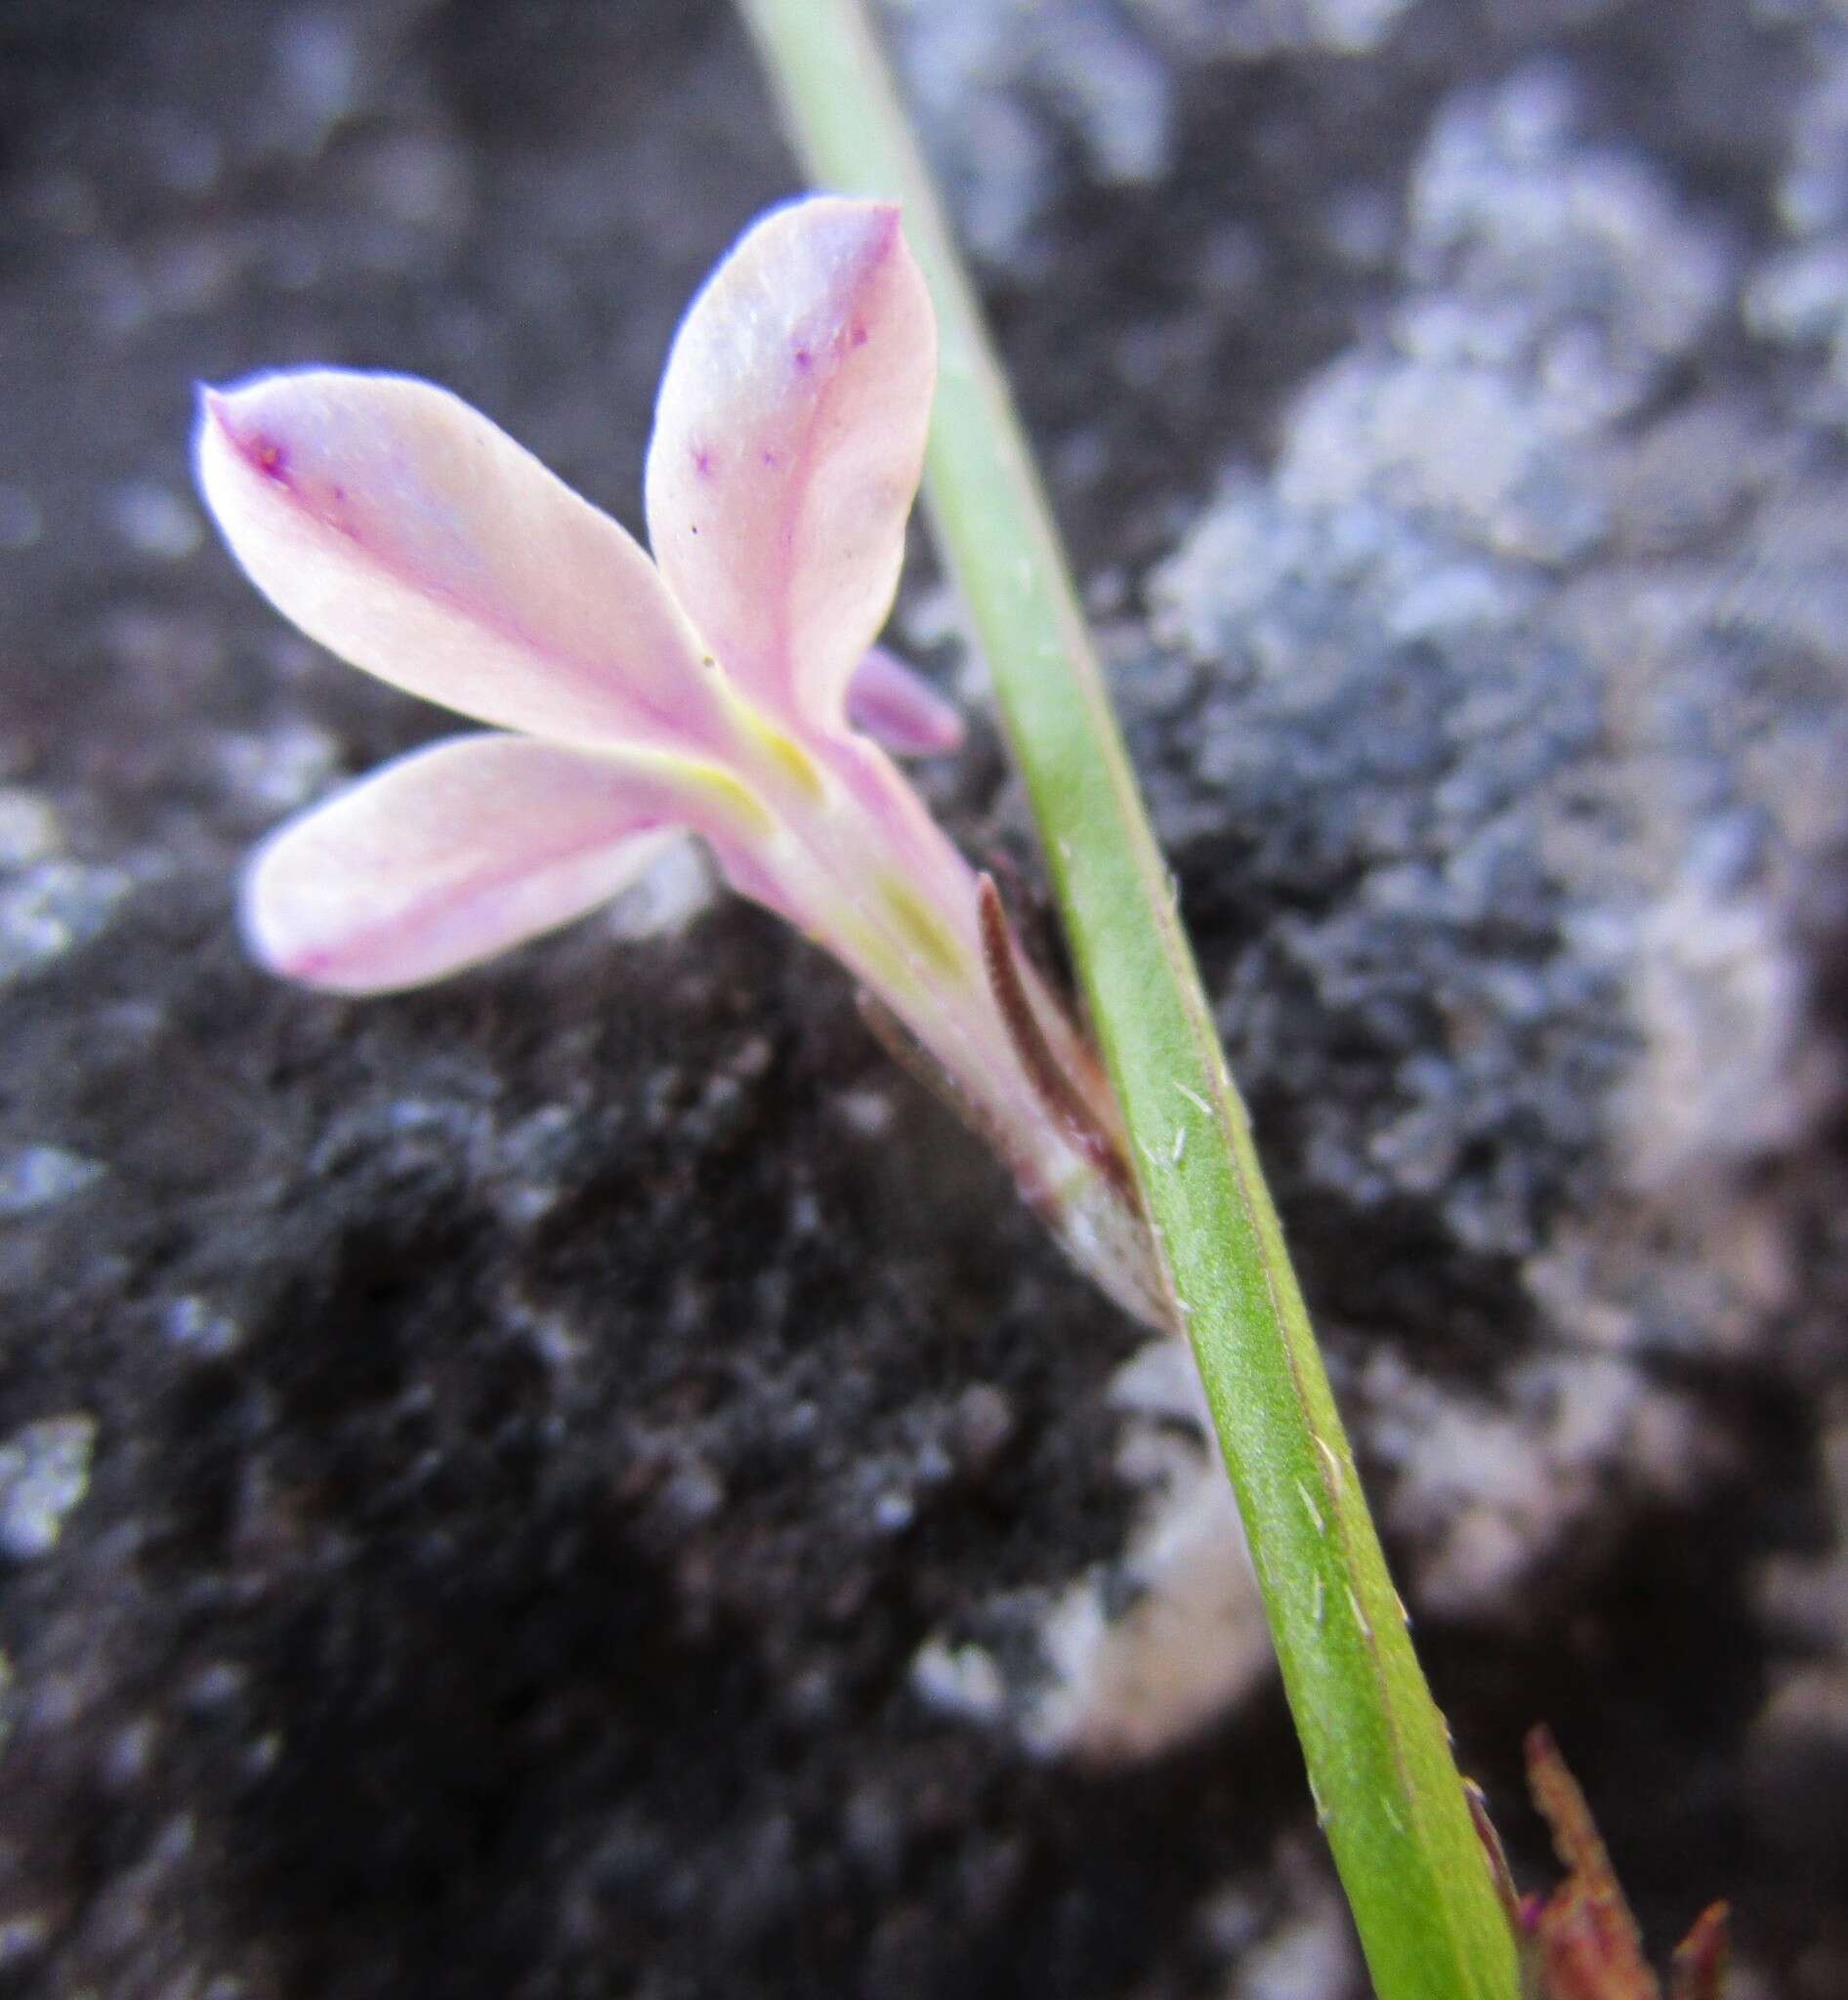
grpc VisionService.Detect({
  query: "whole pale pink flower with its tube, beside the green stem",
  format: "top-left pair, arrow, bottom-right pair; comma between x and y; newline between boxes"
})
198,198 -> 1160,1318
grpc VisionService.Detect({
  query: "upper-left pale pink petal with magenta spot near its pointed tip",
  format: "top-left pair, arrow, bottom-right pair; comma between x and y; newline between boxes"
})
196,368 -> 710,740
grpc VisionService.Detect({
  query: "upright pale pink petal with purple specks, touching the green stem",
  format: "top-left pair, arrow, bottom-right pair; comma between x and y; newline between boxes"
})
648,196 -> 936,724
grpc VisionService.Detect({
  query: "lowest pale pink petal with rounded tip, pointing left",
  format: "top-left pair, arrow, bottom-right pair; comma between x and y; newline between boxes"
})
240,736 -> 703,994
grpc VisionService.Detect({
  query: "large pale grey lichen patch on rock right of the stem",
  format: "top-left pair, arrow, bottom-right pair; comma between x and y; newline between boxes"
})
1150,66 -> 1848,1612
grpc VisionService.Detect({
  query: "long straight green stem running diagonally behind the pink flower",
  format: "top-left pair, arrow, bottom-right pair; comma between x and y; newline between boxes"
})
740,0 -> 1518,2000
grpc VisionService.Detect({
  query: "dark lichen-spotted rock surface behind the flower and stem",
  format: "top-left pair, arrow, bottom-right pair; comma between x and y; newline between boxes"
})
0,0 -> 1848,2000
